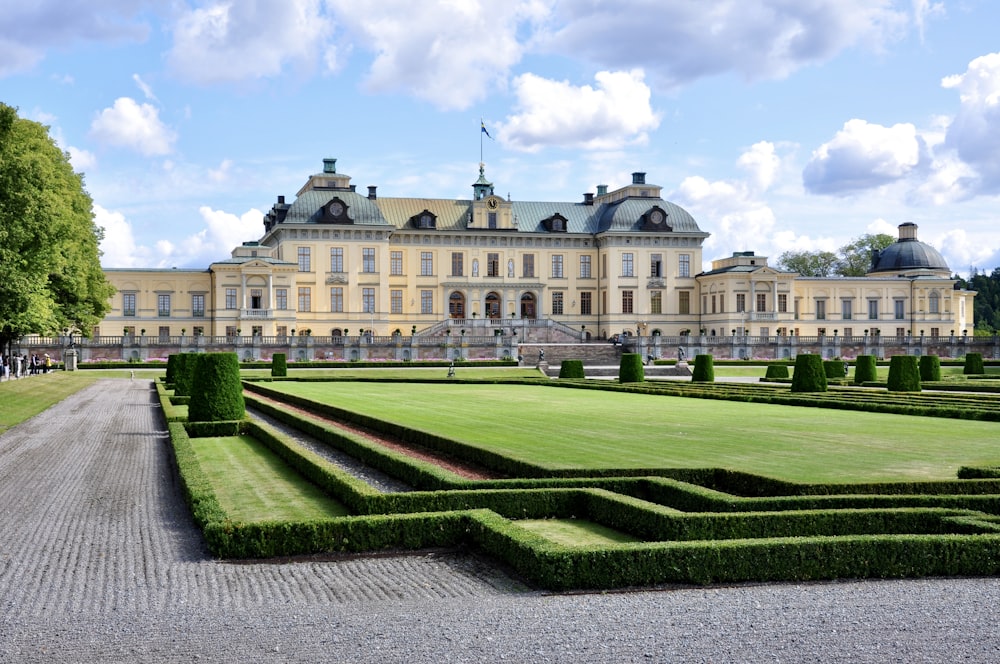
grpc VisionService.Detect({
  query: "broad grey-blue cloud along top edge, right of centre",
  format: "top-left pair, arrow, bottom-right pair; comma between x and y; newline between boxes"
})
538,0 -> 916,86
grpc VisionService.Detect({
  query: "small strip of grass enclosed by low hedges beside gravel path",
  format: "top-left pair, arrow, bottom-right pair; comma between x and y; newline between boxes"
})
191,436 -> 348,522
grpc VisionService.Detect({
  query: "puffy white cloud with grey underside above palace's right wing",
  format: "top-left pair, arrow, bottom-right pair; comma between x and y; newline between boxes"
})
802,119 -> 923,194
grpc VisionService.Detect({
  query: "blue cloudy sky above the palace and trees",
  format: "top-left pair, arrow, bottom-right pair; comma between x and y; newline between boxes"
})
0,0 -> 1000,274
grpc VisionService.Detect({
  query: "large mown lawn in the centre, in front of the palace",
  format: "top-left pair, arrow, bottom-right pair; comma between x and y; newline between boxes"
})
260,382 -> 1000,482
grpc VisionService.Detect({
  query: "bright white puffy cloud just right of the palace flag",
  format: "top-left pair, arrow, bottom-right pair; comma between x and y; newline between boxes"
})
497,70 -> 660,152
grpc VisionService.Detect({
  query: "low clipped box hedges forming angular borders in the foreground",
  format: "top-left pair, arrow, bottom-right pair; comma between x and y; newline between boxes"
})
157,378 -> 1000,590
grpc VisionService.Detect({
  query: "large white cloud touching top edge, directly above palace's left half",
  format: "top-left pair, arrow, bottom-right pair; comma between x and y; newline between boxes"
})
330,0 -> 545,110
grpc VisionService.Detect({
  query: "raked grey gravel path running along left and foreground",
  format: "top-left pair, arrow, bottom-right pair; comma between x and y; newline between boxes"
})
0,380 -> 1000,664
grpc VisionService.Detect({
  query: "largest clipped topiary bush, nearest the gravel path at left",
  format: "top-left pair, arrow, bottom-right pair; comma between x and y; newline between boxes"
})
188,353 -> 246,422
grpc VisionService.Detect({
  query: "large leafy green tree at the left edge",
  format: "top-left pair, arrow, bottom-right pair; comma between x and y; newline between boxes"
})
0,103 -> 114,347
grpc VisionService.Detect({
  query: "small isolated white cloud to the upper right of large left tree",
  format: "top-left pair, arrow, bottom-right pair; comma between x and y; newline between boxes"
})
90,97 -> 177,156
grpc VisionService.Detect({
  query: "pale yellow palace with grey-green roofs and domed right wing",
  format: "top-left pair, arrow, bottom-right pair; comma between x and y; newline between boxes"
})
94,159 -> 975,348
